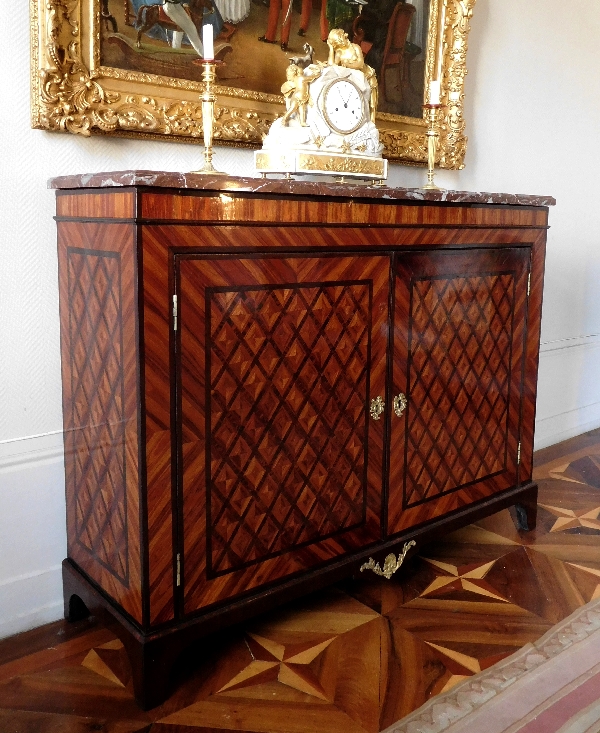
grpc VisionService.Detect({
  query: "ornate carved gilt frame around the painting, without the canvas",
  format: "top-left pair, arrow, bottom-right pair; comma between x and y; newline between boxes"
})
30,0 -> 475,169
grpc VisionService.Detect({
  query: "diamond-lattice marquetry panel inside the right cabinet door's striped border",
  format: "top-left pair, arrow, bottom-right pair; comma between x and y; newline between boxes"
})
405,273 -> 514,506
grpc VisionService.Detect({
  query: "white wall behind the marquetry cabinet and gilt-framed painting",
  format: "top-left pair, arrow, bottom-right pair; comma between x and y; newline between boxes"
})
0,0 -> 600,638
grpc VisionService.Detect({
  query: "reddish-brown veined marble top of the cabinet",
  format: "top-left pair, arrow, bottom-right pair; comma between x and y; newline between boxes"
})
48,170 -> 556,206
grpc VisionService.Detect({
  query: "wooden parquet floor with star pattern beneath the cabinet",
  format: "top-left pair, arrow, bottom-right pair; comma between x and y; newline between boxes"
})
0,430 -> 600,733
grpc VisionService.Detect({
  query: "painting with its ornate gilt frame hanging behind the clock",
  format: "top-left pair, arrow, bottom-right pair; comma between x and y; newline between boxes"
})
31,0 -> 475,168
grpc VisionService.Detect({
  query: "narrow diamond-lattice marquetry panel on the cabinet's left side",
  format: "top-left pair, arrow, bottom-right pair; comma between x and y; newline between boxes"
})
68,250 -> 128,582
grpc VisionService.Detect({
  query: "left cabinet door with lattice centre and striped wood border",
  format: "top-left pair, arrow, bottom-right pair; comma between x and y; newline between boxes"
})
177,256 -> 390,613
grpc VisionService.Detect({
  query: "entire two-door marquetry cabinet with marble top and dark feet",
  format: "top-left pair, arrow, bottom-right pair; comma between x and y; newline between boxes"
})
50,171 -> 554,707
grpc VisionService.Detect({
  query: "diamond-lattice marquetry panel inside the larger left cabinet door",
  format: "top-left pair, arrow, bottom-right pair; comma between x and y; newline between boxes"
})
208,283 -> 370,574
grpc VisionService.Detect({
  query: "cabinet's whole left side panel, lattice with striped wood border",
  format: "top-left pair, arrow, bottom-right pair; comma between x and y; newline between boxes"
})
58,222 -> 142,623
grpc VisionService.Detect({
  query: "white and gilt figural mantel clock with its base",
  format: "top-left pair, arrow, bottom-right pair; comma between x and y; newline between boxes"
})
254,29 -> 387,180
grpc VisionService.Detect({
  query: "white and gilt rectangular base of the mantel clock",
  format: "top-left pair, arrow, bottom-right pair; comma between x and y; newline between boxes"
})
254,150 -> 388,180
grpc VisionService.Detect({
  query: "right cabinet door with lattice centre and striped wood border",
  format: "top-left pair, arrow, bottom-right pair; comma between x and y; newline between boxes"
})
388,248 -> 530,534
